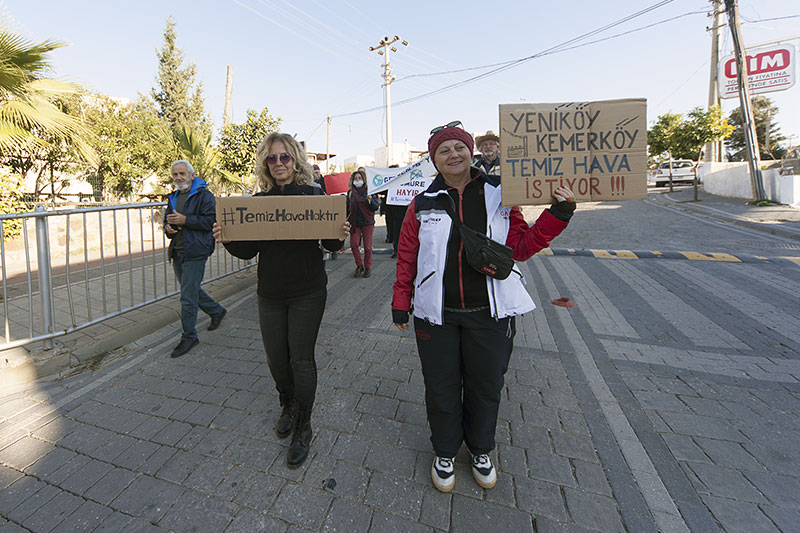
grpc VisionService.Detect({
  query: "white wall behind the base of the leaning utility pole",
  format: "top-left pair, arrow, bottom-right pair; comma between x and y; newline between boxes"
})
700,162 -> 800,205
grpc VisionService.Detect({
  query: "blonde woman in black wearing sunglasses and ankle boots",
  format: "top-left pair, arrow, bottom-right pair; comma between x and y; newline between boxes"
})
213,133 -> 350,468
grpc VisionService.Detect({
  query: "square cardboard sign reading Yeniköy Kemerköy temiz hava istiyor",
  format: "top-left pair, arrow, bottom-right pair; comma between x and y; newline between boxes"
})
500,98 -> 647,206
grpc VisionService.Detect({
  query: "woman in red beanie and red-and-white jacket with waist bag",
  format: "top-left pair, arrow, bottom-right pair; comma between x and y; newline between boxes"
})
392,121 -> 575,492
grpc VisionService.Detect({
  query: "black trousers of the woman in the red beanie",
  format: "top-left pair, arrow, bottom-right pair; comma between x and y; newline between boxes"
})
414,309 -> 516,457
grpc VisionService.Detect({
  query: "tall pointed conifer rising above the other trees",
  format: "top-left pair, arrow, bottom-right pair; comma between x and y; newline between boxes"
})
151,18 -> 208,129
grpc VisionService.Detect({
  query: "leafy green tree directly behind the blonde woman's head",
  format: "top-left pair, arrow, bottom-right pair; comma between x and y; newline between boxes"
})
219,107 -> 281,177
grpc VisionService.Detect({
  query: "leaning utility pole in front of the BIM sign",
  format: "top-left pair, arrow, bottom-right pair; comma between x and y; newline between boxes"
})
725,0 -> 767,201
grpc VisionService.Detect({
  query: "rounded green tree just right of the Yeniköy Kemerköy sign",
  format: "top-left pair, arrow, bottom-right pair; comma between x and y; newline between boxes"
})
647,106 -> 733,161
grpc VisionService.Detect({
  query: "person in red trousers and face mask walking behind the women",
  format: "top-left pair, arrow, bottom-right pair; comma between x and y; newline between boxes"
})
347,167 -> 378,278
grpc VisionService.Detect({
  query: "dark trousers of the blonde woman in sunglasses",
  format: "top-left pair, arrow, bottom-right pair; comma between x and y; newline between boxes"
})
258,289 -> 328,409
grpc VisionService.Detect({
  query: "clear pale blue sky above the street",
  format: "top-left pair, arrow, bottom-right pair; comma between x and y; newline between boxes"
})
0,0 -> 800,164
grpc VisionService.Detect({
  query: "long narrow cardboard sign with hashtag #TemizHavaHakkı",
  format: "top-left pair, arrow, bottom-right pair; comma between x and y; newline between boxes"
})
217,196 -> 347,241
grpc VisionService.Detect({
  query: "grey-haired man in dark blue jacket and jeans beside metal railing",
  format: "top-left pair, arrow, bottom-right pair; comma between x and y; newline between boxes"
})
164,161 -> 227,357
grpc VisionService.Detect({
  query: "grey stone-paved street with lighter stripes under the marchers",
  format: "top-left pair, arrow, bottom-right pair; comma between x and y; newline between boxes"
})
0,241 -> 800,532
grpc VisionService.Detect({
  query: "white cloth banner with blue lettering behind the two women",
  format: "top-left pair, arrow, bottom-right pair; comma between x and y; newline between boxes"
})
365,155 -> 436,205
